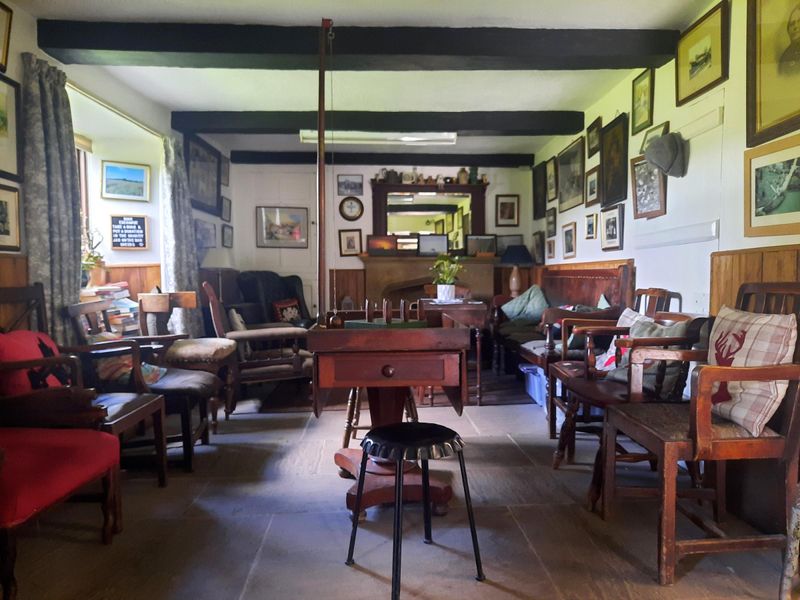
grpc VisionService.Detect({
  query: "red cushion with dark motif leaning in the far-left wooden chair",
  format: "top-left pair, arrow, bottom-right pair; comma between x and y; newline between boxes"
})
0,331 -> 69,396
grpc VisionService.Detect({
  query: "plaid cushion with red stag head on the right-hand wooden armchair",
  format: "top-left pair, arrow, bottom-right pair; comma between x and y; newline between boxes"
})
708,306 -> 797,436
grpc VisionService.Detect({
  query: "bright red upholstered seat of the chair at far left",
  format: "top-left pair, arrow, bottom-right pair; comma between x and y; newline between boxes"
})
0,427 -> 119,528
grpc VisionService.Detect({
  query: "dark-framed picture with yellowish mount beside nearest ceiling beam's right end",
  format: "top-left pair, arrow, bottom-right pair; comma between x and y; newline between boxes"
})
675,0 -> 732,106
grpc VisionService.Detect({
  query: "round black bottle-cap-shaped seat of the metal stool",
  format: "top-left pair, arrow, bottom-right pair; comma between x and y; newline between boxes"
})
361,423 -> 464,461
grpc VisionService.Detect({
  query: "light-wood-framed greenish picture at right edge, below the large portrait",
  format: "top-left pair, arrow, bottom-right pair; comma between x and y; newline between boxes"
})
744,134 -> 800,237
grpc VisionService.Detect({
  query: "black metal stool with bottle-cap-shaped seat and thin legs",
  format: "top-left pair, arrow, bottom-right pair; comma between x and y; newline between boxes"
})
345,422 -> 485,600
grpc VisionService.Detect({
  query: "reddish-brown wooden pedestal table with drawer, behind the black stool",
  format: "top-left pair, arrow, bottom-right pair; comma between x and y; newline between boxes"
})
307,328 -> 469,514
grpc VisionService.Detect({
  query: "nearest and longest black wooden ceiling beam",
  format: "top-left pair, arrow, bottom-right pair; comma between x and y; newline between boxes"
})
37,19 -> 679,71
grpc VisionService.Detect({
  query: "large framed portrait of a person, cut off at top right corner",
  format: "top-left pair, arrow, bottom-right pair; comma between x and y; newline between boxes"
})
752,0 -> 800,146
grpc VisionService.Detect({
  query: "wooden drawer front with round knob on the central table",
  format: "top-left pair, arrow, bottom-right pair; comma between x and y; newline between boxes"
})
317,352 -> 461,388
